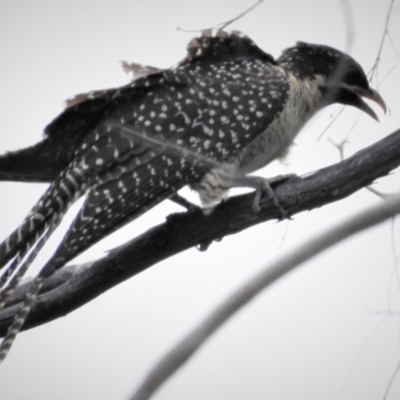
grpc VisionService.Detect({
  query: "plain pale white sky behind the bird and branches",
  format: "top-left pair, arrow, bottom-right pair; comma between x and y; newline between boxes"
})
0,0 -> 400,400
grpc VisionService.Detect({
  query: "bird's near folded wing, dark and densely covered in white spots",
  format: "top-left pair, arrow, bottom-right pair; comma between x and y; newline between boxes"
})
47,35 -> 288,266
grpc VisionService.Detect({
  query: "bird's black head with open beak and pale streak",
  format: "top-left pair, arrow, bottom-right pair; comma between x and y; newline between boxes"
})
277,42 -> 386,120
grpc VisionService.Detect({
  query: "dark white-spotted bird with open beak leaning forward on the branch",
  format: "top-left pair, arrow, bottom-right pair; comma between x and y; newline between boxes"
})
0,30 -> 386,361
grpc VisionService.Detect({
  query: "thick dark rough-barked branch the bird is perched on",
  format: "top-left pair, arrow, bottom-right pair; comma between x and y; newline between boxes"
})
0,129 -> 400,335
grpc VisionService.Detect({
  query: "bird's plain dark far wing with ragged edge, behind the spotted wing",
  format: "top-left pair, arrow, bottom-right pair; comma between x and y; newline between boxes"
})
0,31 -> 275,182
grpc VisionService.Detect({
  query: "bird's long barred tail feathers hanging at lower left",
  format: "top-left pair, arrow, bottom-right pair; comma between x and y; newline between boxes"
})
0,136 -> 104,362
